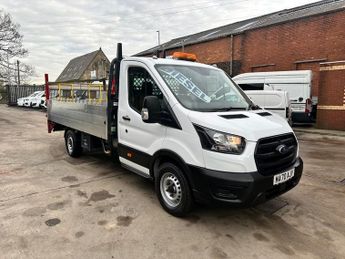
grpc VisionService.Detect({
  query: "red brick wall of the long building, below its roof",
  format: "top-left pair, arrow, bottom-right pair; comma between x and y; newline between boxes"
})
162,11 -> 345,130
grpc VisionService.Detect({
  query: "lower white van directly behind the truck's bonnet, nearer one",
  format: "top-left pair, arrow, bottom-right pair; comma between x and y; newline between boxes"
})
245,90 -> 292,125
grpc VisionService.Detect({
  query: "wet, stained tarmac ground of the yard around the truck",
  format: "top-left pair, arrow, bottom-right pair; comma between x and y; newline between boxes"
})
0,105 -> 345,259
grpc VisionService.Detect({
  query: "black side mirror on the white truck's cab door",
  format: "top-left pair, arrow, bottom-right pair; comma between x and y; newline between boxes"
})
141,96 -> 161,123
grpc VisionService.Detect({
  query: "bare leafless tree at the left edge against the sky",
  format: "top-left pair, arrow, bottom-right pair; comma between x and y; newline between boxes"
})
0,10 -> 35,84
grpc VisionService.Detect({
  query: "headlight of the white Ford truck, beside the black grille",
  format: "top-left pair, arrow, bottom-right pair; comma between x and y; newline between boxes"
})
194,125 -> 246,155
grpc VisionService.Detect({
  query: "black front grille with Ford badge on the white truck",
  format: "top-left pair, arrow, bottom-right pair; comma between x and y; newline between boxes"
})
254,133 -> 297,175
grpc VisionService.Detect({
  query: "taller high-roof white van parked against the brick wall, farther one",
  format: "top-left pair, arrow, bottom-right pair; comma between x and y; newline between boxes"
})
233,70 -> 317,122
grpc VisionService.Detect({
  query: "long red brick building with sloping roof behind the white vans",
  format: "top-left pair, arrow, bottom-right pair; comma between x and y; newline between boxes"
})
137,0 -> 345,130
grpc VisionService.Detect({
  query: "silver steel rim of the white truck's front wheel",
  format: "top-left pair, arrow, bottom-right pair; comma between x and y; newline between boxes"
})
160,172 -> 182,208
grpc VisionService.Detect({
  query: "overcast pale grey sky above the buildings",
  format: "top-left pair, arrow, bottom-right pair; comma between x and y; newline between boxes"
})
0,0 -> 316,83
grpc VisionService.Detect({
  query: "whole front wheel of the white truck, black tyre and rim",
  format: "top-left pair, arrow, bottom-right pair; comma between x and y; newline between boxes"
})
155,163 -> 193,217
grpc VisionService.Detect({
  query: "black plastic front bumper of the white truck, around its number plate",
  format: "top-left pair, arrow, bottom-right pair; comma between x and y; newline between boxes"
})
190,158 -> 303,207
